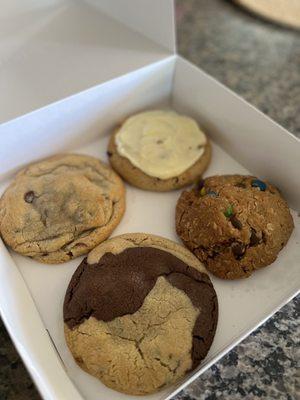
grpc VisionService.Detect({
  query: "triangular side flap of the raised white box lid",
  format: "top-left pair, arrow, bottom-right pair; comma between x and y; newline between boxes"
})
88,0 -> 176,53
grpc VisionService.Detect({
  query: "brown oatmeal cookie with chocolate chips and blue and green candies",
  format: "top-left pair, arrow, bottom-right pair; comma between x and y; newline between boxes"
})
176,175 -> 294,279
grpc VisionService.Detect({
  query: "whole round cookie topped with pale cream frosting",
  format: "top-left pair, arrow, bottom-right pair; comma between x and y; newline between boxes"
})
107,111 -> 211,191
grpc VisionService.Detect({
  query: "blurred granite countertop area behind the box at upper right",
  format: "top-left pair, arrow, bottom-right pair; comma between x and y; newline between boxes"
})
176,0 -> 300,136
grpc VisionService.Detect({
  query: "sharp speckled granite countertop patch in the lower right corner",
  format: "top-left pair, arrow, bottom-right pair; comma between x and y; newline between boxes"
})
176,296 -> 300,400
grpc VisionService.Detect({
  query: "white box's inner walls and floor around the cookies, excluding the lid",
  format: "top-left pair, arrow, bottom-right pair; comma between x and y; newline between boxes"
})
0,56 -> 300,400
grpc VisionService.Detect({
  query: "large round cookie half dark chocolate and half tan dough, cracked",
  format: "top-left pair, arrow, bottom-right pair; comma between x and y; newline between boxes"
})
64,233 -> 218,395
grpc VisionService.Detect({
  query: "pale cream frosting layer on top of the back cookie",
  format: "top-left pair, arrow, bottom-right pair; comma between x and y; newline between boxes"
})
115,111 -> 207,179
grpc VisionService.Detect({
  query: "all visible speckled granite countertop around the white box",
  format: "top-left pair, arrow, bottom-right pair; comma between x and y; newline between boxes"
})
0,0 -> 300,400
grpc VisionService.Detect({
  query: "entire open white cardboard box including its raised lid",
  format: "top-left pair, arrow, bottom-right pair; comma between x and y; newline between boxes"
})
0,0 -> 300,400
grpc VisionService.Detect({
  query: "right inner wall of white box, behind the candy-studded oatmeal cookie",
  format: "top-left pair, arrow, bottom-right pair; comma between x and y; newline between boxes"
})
172,57 -> 300,210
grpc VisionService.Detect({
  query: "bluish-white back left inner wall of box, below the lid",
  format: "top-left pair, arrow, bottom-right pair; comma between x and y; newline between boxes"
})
0,56 -> 174,177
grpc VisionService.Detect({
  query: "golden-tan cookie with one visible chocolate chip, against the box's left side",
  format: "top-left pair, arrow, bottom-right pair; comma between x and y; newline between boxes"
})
0,154 -> 125,263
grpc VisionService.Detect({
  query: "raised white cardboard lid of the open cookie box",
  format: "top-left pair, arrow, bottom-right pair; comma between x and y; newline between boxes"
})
0,0 -> 175,123
